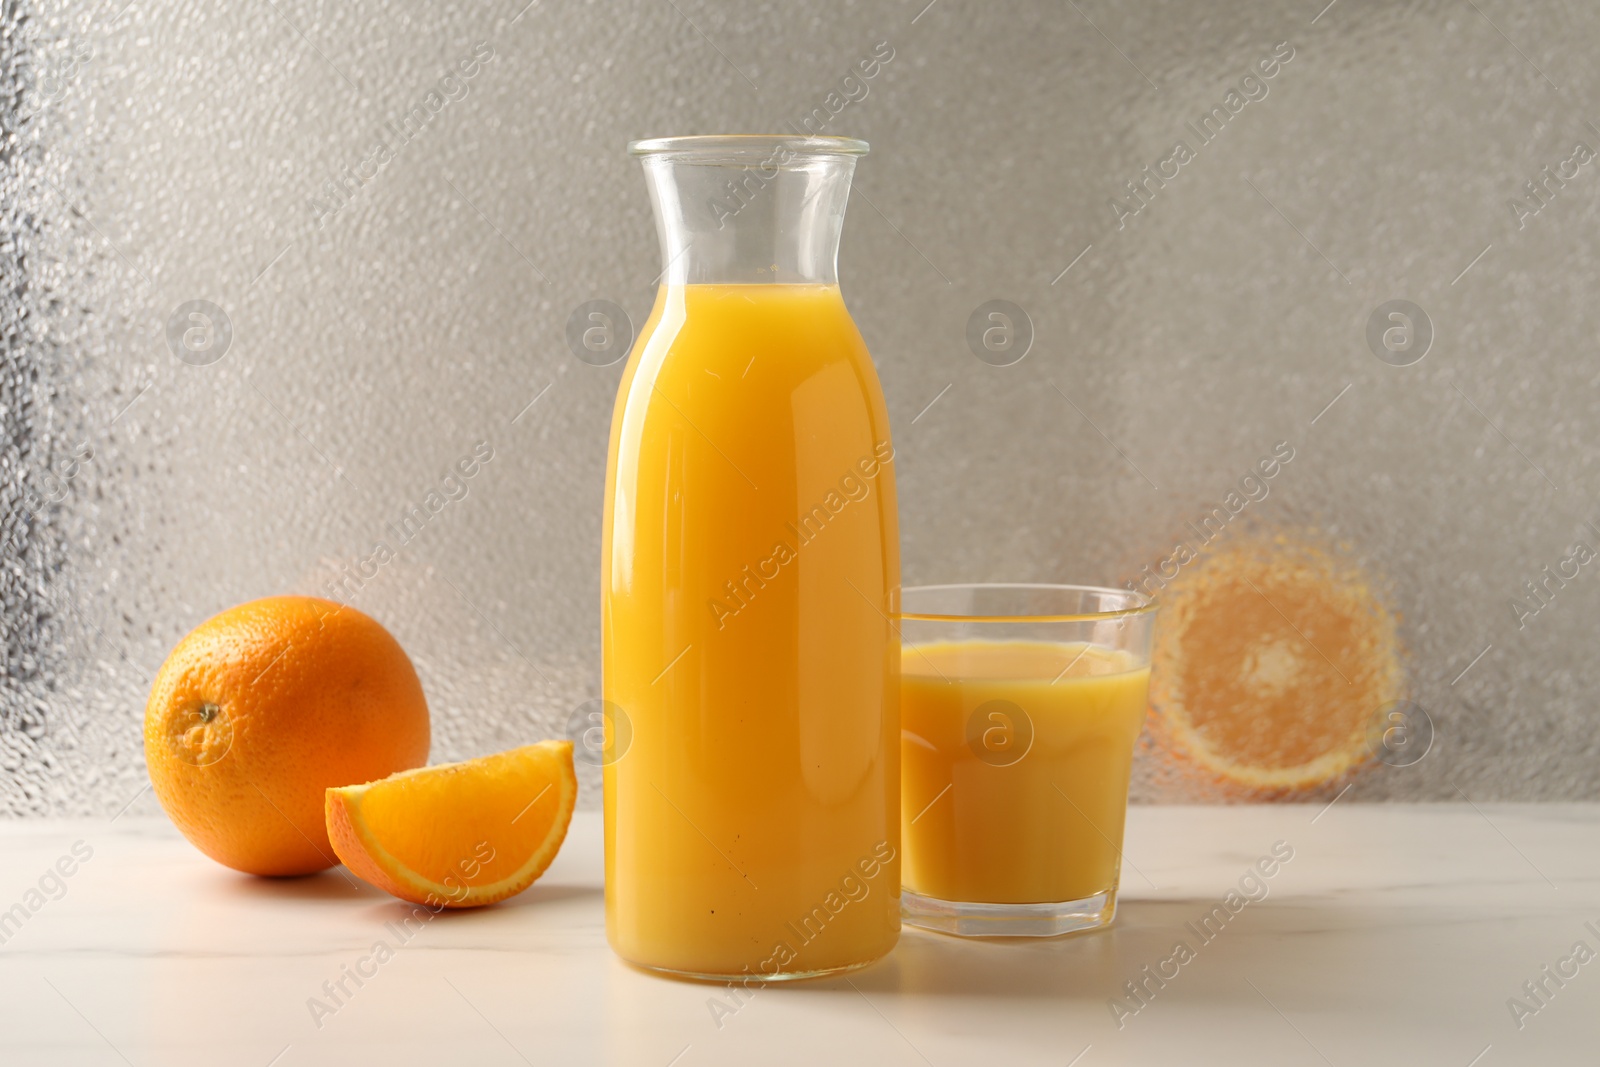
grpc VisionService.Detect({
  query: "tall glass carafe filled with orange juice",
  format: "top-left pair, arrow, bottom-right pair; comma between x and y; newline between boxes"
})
602,136 -> 901,981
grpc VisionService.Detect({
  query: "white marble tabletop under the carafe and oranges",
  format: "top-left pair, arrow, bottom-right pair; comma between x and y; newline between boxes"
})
0,803 -> 1600,1067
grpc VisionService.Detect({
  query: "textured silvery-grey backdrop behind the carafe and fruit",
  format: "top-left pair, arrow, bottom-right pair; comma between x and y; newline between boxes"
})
0,0 -> 1600,814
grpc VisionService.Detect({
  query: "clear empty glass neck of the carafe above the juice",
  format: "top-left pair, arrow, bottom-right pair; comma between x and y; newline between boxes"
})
643,150 -> 856,286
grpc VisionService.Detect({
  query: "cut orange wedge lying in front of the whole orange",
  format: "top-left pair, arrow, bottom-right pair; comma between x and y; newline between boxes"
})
326,741 -> 578,907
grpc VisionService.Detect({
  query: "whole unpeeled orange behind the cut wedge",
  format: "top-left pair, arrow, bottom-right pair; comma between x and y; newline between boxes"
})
144,597 -> 429,875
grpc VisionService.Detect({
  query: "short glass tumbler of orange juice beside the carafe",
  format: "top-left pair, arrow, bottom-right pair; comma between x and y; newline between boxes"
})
899,585 -> 1155,936
